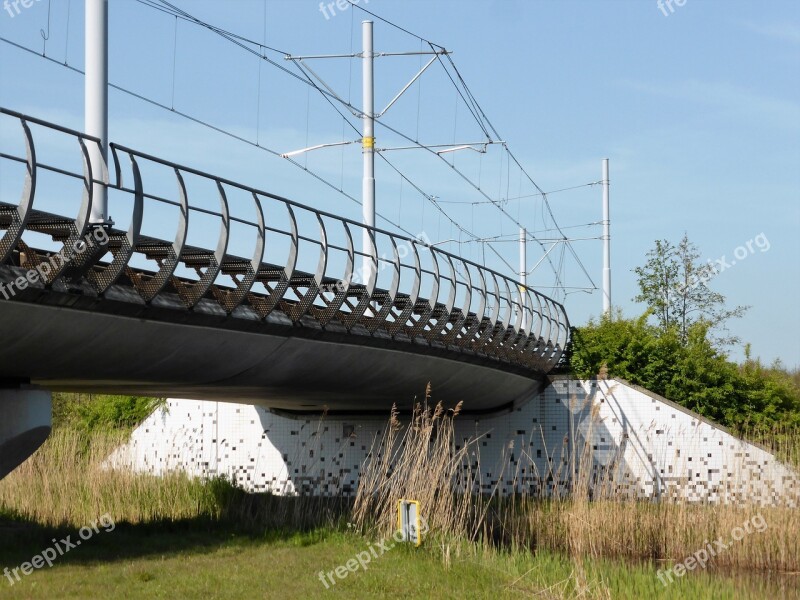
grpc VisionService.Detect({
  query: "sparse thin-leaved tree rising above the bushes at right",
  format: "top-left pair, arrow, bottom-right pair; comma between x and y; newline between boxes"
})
634,234 -> 749,345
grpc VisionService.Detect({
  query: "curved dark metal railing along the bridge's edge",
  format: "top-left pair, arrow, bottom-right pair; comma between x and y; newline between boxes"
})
0,108 -> 569,373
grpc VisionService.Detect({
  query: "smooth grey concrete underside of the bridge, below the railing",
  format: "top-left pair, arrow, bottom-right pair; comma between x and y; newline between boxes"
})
0,267 -> 543,414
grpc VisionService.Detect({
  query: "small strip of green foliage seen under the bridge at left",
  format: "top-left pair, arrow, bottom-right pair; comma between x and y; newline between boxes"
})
53,393 -> 163,431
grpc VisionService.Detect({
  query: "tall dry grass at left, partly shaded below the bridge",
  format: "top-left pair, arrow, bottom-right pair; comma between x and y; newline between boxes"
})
0,428 -> 350,530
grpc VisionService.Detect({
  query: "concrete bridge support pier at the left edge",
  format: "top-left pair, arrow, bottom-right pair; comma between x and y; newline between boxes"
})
0,386 -> 53,479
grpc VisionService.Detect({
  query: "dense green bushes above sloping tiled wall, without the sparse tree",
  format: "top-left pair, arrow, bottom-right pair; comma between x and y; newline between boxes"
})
570,311 -> 800,433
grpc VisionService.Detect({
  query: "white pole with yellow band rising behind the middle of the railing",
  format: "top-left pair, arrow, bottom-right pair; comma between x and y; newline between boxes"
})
361,21 -> 377,284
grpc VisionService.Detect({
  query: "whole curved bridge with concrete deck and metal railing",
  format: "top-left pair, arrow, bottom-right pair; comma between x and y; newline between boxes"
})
0,109 -> 569,414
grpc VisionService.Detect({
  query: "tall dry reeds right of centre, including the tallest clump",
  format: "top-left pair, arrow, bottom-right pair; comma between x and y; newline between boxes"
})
353,394 -> 800,572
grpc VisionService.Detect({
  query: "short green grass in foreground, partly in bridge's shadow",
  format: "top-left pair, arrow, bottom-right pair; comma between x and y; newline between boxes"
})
0,519 -> 800,600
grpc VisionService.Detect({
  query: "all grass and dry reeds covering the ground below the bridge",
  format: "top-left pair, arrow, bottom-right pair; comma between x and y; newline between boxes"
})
0,394 -> 800,599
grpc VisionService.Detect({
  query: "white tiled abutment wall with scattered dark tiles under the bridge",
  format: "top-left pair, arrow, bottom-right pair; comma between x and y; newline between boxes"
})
110,379 -> 800,506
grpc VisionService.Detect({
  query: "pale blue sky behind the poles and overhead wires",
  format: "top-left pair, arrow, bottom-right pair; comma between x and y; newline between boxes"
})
0,0 -> 800,366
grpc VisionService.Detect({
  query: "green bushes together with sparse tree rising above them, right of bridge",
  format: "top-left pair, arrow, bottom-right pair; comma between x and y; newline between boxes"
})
580,235 -> 800,435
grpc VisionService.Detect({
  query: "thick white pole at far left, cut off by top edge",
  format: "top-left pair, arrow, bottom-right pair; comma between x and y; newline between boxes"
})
84,0 -> 109,224
